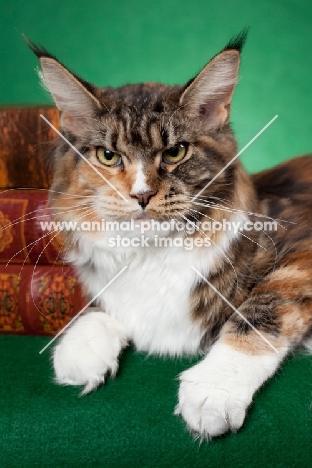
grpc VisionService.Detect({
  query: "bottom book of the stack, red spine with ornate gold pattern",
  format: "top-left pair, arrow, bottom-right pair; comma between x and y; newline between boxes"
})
0,265 -> 86,335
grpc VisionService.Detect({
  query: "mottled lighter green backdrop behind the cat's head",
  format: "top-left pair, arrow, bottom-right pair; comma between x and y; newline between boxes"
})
0,0 -> 312,171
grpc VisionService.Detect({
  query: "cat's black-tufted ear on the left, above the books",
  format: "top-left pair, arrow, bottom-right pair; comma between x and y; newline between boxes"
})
27,40 -> 100,135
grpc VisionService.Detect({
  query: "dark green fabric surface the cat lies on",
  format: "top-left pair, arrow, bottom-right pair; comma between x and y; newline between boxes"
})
0,336 -> 312,468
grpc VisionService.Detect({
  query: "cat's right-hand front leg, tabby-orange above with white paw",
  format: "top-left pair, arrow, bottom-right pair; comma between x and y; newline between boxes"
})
177,264 -> 312,438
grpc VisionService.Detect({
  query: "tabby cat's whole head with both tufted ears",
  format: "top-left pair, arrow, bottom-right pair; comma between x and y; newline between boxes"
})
31,32 -> 249,236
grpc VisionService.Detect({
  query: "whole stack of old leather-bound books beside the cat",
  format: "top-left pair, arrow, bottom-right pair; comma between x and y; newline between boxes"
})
0,107 -> 86,335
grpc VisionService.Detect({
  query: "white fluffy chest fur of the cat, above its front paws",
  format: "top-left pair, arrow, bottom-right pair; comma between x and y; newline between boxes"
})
71,229 -> 236,355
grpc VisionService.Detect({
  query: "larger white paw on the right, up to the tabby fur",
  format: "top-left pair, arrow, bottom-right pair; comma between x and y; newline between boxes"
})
175,344 -> 279,439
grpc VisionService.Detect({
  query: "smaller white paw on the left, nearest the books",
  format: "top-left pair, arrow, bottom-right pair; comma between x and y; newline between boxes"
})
53,312 -> 127,394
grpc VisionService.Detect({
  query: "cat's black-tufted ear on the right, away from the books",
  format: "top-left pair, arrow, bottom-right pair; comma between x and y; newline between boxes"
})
180,30 -> 247,128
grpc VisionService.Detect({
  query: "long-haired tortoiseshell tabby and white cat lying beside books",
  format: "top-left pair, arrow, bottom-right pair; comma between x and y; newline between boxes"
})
29,31 -> 312,439
